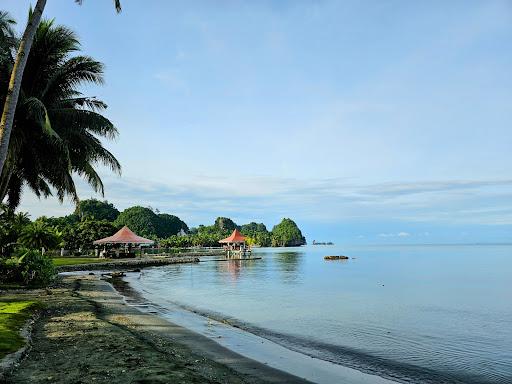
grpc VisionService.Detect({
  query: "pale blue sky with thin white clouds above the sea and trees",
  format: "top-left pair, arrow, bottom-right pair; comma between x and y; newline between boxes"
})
4,0 -> 512,244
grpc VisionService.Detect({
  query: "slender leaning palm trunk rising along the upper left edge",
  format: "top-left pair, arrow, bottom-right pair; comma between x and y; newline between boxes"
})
0,0 -> 46,171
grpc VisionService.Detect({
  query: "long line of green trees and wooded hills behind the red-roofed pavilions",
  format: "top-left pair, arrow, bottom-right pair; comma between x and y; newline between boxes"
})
0,199 -> 306,254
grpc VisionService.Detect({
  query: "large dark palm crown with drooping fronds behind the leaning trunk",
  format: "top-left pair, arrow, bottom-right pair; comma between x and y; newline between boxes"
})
0,20 -> 121,207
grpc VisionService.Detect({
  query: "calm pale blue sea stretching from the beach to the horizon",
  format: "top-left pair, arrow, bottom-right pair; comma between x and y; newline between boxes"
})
123,245 -> 512,383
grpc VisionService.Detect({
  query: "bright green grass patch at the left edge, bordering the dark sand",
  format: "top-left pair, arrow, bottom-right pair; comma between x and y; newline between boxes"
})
0,301 -> 36,358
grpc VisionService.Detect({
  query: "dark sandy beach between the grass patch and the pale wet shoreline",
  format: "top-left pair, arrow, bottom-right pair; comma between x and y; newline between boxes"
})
3,275 -> 307,384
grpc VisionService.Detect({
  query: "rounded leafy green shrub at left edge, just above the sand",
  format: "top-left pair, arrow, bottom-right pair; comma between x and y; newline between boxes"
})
0,250 -> 55,286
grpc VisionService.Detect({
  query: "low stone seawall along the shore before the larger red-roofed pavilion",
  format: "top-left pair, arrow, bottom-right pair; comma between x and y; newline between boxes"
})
57,256 -> 199,272
